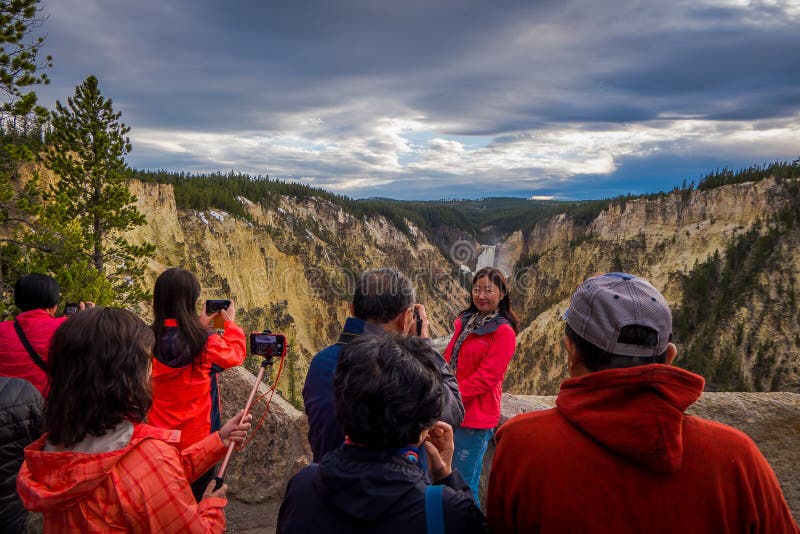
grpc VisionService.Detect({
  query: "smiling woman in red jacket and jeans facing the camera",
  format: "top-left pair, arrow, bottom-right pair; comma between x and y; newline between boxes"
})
444,267 -> 519,501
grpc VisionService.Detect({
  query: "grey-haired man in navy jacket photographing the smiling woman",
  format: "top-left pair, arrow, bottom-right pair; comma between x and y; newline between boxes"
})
303,268 -> 464,462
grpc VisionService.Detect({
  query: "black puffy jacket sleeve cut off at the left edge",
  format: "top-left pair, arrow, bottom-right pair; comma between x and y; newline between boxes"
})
0,377 -> 42,533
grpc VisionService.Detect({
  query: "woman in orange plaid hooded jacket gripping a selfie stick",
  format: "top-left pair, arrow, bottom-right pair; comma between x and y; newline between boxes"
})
17,308 -> 250,533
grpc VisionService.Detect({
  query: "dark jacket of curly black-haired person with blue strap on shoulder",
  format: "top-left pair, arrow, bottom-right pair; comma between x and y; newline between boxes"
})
277,445 -> 487,534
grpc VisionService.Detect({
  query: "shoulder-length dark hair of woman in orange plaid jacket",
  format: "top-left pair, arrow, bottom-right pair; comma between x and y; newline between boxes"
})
44,307 -> 153,447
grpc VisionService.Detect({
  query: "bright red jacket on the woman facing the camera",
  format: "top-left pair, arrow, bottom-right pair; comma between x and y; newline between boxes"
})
443,316 -> 517,429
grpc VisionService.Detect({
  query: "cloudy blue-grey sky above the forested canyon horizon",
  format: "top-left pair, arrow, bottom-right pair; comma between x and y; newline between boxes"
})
31,0 -> 800,199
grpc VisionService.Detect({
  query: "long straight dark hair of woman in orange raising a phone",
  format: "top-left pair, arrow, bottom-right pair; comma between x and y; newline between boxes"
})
153,267 -> 208,364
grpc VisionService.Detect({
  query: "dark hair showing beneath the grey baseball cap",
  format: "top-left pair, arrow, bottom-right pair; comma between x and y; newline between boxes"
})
564,324 -> 667,373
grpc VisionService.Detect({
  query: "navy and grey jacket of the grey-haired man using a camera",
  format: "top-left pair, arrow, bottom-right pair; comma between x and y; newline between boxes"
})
303,317 -> 464,463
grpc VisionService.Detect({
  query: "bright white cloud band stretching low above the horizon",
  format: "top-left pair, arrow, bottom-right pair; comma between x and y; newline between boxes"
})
133,103 -> 800,196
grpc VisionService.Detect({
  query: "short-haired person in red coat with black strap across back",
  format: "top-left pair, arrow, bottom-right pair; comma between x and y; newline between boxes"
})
0,273 -> 94,397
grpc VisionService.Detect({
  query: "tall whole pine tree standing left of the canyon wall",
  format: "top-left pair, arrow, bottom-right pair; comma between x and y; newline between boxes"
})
44,76 -> 155,304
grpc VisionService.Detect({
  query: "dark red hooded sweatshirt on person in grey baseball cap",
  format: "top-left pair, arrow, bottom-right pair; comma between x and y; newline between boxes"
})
487,365 -> 800,534
